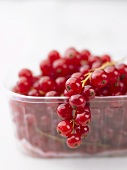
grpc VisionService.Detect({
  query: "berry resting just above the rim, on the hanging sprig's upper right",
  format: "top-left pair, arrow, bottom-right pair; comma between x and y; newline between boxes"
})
82,85 -> 95,101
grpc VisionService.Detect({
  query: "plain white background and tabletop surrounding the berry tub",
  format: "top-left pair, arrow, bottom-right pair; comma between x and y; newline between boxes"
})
0,0 -> 127,170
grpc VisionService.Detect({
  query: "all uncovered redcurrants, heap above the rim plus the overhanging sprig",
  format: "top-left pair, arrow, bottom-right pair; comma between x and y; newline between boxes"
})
12,48 -> 127,148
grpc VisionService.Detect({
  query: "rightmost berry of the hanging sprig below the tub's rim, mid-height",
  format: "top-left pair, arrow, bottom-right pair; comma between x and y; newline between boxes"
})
75,110 -> 91,126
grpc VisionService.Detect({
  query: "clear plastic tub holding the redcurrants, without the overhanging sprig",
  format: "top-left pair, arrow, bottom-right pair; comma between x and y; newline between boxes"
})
4,63 -> 127,158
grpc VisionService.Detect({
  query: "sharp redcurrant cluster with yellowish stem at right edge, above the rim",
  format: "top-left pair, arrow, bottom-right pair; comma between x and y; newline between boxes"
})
90,62 -> 127,96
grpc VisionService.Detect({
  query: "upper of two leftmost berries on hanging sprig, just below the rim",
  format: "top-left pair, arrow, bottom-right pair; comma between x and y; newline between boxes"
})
57,103 -> 73,119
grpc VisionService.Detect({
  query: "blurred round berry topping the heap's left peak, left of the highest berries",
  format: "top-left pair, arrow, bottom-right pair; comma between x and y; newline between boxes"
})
48,50 -> 60,63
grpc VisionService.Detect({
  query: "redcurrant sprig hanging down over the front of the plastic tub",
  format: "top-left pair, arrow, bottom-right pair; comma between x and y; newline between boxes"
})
57,73 -> 95,148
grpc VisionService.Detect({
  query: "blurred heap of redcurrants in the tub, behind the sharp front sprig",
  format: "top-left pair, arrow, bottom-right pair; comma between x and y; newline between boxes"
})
13,48 -> 110,96
